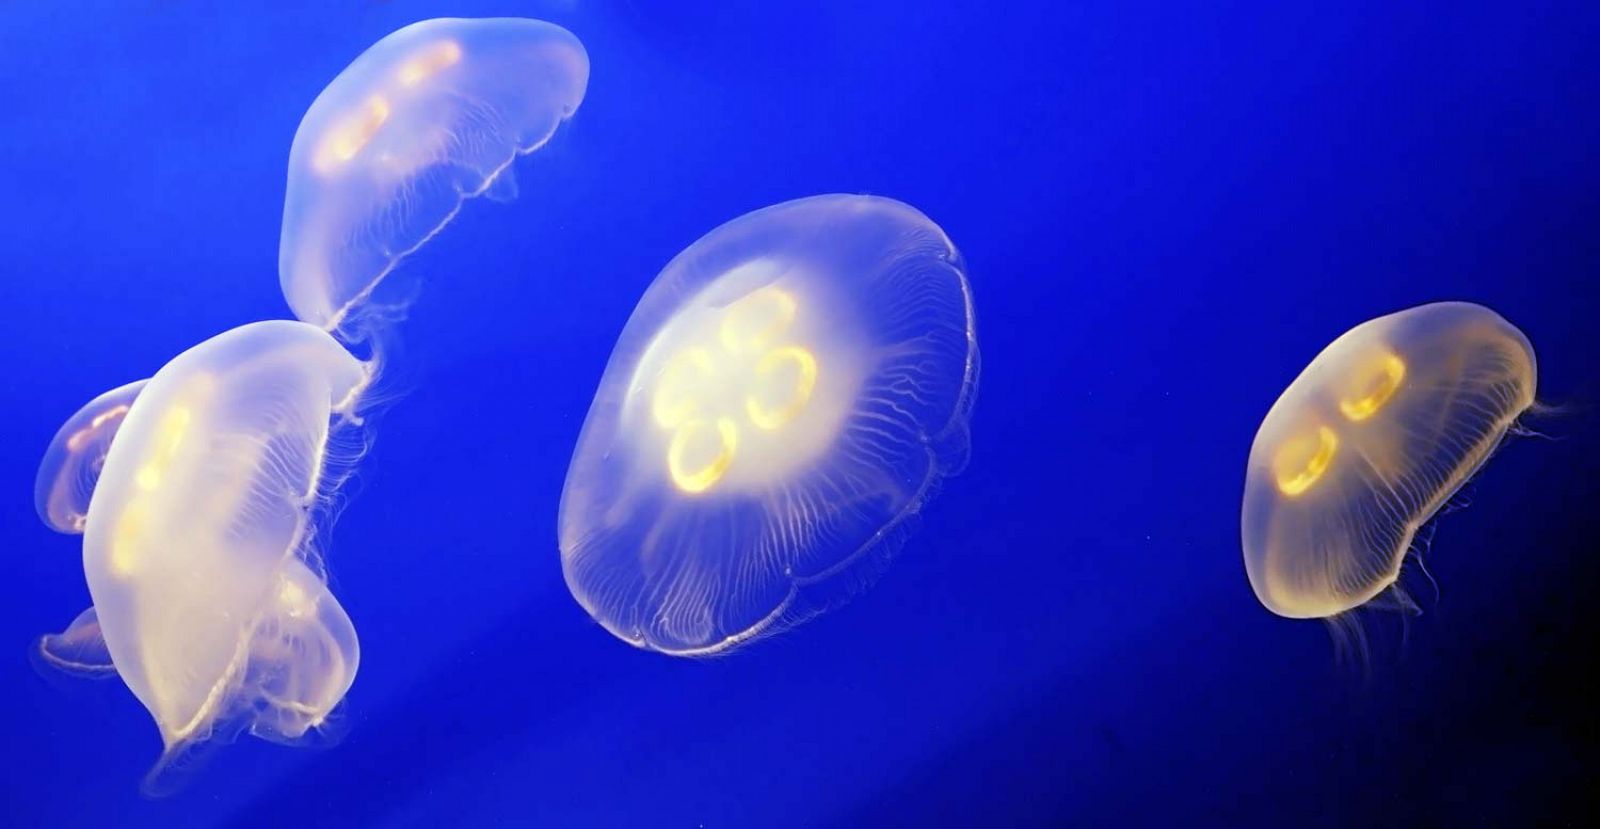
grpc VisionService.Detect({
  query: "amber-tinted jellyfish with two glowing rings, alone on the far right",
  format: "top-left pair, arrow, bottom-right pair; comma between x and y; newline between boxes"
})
1242,302 -> 1536,618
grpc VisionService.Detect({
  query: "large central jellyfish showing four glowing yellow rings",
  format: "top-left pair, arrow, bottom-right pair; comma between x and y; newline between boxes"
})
560,195 -> 978,655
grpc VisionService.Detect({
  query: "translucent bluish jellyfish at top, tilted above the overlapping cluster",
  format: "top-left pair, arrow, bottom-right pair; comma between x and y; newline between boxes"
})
278,18 -> 589,336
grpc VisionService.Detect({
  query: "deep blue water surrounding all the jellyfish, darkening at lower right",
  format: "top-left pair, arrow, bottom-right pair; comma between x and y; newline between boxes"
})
0,0 -> 1600,827
